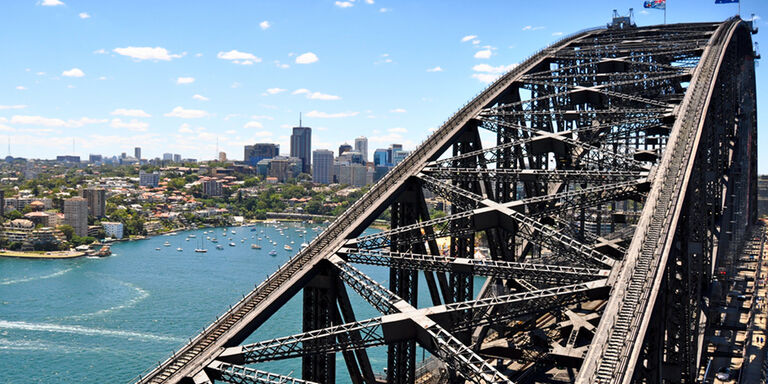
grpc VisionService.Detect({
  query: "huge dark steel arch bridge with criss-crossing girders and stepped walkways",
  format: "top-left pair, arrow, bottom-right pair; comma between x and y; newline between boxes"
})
132,19 -> 756,384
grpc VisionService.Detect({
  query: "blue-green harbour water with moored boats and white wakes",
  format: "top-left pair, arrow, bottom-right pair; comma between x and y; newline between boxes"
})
0,223 -> 472,384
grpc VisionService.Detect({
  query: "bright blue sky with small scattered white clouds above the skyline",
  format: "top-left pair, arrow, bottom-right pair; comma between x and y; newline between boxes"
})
0,0 -> 768,173
